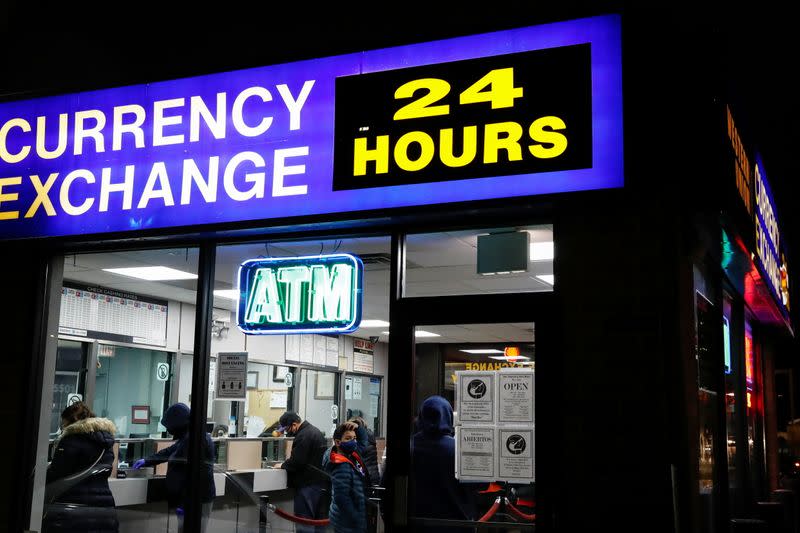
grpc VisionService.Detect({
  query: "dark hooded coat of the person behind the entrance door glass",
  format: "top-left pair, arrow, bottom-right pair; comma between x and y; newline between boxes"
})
410,396 -> 475,531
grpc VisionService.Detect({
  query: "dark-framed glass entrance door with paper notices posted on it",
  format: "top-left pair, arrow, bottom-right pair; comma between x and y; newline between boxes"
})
387,293 -> 559,530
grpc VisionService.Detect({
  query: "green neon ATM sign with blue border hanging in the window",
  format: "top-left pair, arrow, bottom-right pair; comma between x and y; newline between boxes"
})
237,254 -> 364,335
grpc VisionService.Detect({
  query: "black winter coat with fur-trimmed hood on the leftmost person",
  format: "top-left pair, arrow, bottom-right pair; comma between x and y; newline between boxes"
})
43,418 -> 119,533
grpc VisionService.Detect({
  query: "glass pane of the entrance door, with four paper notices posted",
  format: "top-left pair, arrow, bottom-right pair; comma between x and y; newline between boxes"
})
409,323 -> 536,529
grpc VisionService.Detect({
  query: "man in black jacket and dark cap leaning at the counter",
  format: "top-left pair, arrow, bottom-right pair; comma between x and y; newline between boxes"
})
274,411 -> 330,532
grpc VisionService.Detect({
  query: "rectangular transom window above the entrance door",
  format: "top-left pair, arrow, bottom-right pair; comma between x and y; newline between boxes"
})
405,225 -> 555,296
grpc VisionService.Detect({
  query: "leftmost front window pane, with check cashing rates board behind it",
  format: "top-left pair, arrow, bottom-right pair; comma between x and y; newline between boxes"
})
30,248 -> 197,531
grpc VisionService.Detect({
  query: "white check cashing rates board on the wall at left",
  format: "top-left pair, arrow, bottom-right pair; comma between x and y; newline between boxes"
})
58,282 -> 168,346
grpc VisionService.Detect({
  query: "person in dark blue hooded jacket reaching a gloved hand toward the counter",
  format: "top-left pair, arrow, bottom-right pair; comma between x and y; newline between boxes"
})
133,403 -> 217,532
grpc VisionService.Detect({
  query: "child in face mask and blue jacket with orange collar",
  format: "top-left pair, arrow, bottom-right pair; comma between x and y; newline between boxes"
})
322,422 -> 369,533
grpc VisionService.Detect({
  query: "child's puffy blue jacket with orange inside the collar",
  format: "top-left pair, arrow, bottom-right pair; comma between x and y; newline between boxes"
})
322,446 -> 367,533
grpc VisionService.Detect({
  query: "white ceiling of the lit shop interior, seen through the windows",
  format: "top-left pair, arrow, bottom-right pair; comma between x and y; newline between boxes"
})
64,225 -> 553,343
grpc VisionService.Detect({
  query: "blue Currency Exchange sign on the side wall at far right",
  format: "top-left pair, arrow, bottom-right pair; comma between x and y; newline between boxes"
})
753,154 -> 791,315
